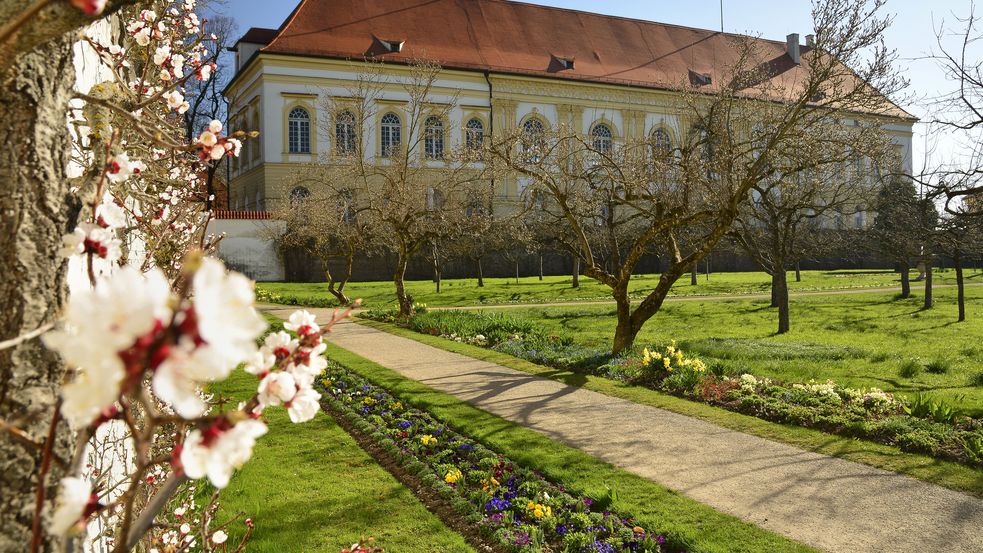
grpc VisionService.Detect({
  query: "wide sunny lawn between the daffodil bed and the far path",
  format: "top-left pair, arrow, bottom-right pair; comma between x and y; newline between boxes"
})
482,287 -> 983,416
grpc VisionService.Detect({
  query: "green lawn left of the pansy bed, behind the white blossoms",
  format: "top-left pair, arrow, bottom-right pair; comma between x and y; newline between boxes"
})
210,316 -> 474,553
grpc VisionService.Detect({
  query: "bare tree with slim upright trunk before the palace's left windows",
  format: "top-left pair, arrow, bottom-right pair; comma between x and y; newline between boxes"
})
308,61 -> 491,315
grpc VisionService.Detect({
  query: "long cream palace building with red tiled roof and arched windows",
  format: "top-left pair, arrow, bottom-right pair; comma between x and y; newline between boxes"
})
225,0 -> 915,278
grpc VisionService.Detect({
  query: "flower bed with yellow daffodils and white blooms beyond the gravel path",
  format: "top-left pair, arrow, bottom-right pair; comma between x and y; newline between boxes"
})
361,311 -> 983,466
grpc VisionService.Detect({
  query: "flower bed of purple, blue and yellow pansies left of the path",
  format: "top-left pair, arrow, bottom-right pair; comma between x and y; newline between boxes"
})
320,363 -> 680,553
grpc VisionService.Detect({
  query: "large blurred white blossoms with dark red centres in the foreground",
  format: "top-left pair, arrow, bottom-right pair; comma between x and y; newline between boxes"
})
45,258 -> 327,539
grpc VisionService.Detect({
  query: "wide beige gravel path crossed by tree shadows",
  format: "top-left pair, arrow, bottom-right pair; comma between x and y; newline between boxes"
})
264,310 -> 983,553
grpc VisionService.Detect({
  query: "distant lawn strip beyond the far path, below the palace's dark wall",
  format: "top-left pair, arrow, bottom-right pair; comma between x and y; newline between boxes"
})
257,270 -> 983,307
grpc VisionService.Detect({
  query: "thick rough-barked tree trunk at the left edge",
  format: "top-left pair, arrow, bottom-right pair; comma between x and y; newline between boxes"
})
0,32 -> 80,551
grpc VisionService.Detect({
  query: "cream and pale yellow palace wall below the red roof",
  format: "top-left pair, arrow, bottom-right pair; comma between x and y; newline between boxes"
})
227,53 -> 924,280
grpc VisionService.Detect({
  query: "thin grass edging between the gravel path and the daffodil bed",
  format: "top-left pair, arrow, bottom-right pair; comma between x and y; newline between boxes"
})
359,320 -> 983,497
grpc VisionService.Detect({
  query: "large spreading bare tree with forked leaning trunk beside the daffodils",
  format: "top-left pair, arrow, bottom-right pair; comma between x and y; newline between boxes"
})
493,0 -> 904,353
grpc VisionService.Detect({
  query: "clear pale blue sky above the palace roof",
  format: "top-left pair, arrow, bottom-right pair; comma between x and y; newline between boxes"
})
219,0 -> 970,171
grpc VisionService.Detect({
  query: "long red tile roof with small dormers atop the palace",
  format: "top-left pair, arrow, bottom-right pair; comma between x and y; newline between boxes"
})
252,0 -> 908,117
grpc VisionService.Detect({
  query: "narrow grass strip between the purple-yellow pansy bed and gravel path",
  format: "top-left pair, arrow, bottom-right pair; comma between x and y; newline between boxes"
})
328,344 -> 813,553
